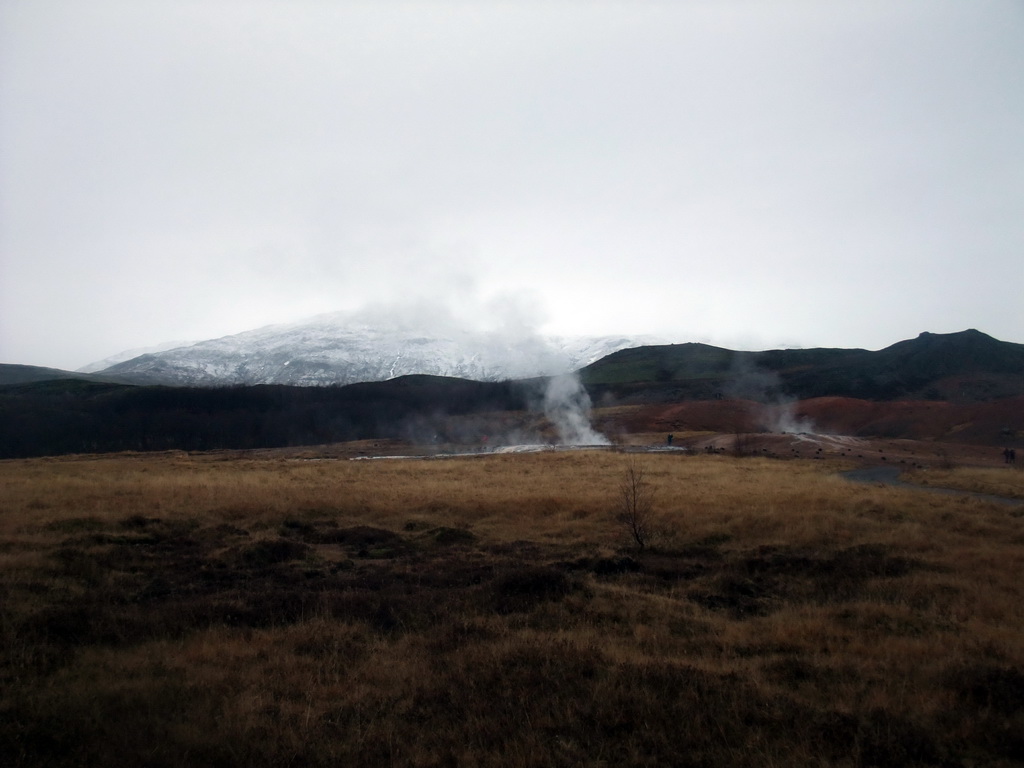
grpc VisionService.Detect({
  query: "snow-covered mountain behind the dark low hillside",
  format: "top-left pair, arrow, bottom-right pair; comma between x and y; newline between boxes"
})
87,313 -> 664,386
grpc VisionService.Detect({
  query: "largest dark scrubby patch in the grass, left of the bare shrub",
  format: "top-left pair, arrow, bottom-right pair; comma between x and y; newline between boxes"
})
25,517 -> 598,649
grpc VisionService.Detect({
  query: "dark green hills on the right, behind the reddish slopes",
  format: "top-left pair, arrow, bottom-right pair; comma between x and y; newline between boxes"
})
581,330 -> 1024,402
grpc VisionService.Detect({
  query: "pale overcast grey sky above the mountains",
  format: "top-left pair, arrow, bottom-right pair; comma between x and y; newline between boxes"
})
0,0 -> 1024,369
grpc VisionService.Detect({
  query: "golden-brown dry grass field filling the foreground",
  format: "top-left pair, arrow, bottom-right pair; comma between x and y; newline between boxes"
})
0,452 -> 1024,766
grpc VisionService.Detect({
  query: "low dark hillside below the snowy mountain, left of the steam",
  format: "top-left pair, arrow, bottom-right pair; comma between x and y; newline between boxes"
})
0,376 -> 527,459
